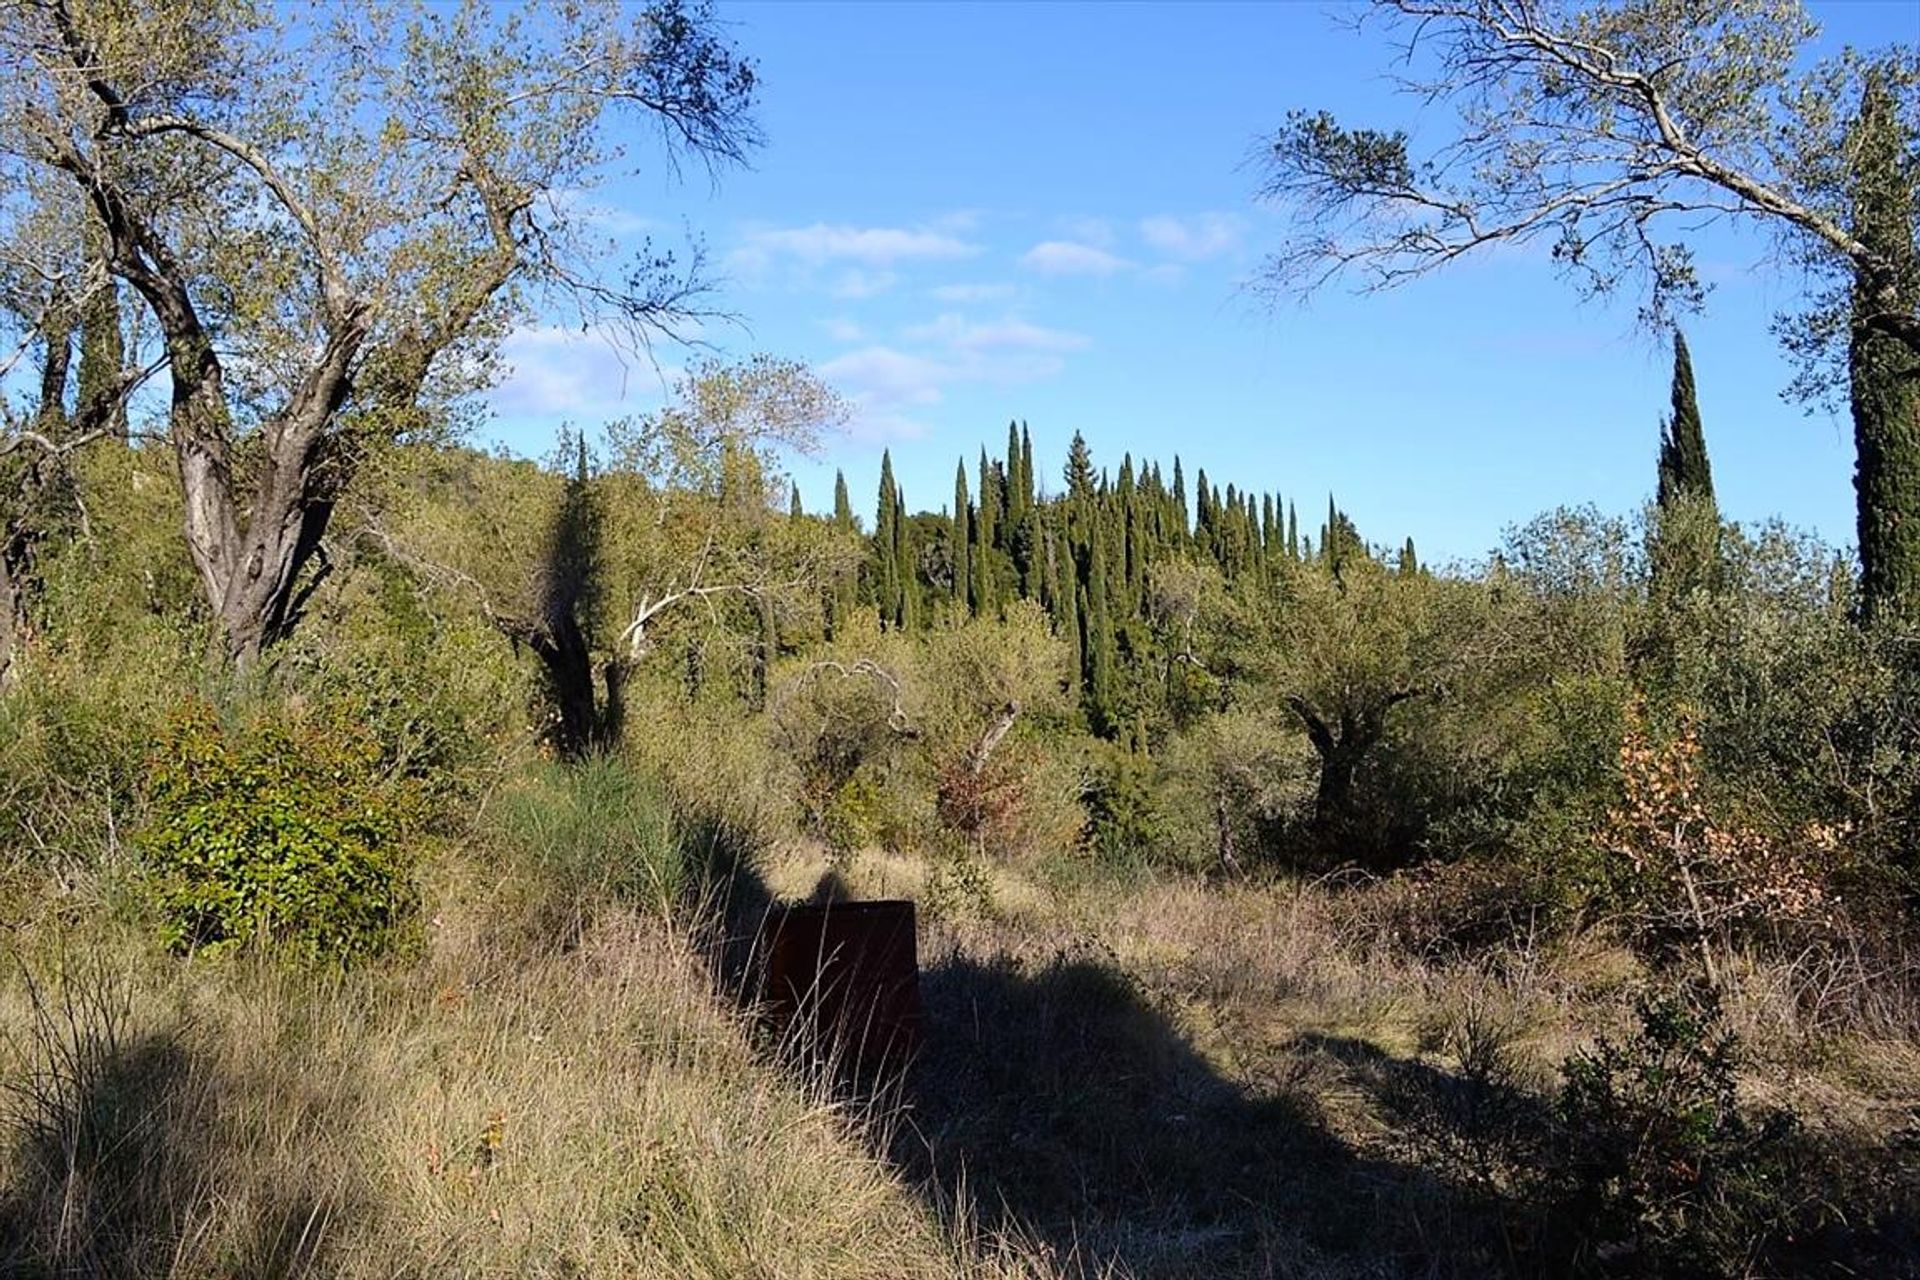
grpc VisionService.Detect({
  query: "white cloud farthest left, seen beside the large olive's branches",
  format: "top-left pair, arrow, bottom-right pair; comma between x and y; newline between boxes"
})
492,324 -> 676,420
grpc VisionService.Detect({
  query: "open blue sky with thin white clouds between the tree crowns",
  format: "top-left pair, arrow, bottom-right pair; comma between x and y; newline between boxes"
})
490,0 -> 1920,560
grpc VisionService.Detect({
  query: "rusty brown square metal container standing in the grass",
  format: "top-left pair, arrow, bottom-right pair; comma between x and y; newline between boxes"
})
764,900 -> 920,1075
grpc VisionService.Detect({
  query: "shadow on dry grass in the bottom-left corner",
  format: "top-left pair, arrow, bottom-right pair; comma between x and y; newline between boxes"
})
0,1006 -> 351,1280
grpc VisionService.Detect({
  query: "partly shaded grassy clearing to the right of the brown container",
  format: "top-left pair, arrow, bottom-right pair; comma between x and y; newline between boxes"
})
764,852 -> 1920,1280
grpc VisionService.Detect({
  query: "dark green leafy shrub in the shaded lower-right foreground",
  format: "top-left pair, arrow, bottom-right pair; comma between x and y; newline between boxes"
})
1555,986 -> 1797,1276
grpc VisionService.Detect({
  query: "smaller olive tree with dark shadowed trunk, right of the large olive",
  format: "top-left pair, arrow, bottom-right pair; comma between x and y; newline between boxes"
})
370,355 -> 858,754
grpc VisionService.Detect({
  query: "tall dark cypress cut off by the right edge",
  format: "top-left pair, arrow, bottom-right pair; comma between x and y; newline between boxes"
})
1847,65 -> 1920,624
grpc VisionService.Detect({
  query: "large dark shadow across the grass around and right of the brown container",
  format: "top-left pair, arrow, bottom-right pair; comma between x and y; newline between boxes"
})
705,850 -> 1540,1280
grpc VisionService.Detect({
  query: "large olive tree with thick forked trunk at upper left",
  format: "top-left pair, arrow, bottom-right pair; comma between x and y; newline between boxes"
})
0,0 -> 755,664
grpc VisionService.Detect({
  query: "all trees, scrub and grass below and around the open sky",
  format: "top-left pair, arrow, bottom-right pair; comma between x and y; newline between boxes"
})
0,0 -> 1920,1280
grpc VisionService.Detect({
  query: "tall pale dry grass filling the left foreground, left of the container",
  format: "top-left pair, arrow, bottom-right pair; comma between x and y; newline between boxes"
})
0,855 -> 1059,1280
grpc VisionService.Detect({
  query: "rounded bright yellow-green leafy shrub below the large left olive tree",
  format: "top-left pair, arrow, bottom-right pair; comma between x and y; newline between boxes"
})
136,702 -> 424,961
